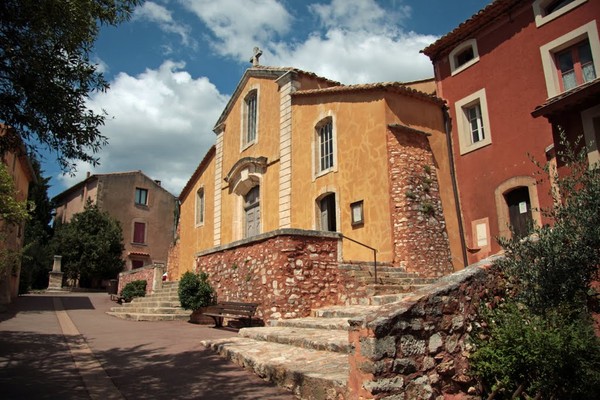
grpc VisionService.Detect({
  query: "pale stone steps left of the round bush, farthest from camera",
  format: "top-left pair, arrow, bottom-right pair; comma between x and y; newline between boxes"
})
107,282 -> 192,321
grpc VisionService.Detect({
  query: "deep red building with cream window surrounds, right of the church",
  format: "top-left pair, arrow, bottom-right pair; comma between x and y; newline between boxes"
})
423,0 -> 600,263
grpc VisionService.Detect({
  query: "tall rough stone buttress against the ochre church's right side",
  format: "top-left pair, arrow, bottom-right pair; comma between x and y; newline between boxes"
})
387,130 -> 453,278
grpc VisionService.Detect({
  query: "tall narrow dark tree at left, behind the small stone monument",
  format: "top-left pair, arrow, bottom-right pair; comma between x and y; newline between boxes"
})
19,157 -> 53,293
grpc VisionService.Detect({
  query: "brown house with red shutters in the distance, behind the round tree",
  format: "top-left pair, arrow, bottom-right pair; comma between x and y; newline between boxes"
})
52,171 -> 176,270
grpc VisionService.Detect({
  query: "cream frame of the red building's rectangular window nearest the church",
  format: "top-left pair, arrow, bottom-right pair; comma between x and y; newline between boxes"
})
454,88 -> 492,155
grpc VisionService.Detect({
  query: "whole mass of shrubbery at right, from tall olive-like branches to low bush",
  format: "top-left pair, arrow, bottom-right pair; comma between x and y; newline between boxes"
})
470,137 -> 600,400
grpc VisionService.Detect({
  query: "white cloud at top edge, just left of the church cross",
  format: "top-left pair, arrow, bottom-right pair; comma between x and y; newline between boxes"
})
181,0 -> 292,62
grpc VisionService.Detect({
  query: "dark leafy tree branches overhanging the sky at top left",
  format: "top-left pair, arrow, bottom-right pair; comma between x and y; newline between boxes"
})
0,0 -> 141,171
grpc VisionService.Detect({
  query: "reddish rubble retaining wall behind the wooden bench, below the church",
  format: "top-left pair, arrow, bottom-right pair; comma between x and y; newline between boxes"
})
196,229 -> 348,322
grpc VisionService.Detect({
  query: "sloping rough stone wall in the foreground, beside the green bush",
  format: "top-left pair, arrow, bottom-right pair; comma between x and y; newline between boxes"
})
348,265 -> 498,400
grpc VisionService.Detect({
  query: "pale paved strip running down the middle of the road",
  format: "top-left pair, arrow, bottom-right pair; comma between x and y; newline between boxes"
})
52,297 -> 125,400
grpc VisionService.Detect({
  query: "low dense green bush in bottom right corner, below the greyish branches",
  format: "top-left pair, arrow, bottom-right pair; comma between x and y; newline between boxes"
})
470,302 -> 600,400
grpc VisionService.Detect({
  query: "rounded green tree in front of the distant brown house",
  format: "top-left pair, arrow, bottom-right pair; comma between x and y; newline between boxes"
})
52,200 -> 125,286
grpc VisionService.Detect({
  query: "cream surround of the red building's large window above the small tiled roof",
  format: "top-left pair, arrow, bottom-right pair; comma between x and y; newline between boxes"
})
540,20 -> 600,98
